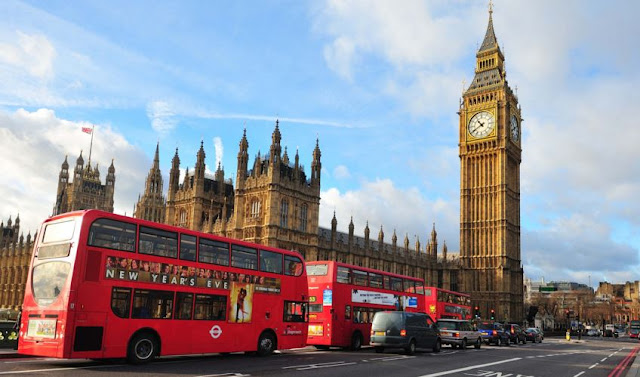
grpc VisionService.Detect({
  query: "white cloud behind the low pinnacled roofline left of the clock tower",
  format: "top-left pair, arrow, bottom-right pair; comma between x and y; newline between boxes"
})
319,179 -> 460,252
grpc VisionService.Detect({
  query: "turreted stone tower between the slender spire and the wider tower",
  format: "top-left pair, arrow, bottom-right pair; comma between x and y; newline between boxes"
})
165,142 -> 233,229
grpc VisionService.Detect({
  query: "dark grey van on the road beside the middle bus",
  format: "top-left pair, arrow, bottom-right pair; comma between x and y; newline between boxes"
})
371,311 -> 442,355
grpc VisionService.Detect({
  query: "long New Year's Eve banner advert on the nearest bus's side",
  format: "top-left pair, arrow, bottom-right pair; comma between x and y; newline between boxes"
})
105,256 -> 280,294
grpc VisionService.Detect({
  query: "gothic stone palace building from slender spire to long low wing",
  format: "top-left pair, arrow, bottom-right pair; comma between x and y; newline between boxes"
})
136,121 -> 463,290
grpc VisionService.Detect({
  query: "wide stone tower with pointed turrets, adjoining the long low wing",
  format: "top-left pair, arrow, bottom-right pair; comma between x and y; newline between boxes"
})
226,121 -> 321,260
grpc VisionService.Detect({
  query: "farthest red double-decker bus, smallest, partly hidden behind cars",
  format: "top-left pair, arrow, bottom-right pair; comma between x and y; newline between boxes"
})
423,287 -> 471,320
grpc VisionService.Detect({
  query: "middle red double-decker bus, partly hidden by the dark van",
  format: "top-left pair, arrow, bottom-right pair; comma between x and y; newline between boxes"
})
306,261 -> 424,350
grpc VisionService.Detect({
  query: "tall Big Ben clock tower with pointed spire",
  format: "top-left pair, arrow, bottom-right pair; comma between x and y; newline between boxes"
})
458,4 -> 524,321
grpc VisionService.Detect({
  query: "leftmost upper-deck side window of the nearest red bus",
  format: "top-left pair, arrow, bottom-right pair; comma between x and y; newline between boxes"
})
89,219 -> 136,251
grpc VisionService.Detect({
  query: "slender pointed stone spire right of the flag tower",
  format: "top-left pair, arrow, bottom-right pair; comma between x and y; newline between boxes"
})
133,143 -> 166,223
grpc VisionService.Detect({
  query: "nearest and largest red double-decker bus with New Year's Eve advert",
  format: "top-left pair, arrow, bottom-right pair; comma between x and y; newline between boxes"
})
18,210 -> 308,363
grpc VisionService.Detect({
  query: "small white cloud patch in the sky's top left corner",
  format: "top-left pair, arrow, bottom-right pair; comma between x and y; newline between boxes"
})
0,31 -> 56,80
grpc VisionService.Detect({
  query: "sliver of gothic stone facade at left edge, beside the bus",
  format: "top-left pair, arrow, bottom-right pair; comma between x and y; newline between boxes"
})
0,216 -> 36,310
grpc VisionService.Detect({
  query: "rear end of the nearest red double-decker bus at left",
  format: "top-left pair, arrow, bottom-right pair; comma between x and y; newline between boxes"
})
18,212 -> 83,358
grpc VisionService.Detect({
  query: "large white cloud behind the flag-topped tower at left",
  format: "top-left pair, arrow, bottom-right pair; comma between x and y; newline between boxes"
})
0,109 -> 151,234
